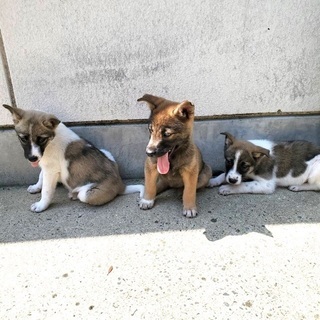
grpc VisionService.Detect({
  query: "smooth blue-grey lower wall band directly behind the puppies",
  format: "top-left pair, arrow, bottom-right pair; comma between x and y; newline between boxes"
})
0,116 -> 320,186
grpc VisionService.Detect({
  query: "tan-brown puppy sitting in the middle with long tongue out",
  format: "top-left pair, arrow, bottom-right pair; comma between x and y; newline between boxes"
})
138,94 -> 212,218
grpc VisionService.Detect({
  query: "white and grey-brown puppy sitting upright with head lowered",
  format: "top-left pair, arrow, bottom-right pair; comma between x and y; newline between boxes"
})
3,105 -> 144,212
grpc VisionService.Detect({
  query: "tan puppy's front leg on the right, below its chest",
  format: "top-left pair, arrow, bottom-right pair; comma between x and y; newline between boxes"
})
181,171 -> 198,218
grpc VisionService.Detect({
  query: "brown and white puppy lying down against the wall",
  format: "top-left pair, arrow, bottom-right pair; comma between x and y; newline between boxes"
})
209,132 -> 320,195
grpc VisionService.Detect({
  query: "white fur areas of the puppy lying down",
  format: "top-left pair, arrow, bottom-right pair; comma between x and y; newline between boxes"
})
208,140 -> 320,195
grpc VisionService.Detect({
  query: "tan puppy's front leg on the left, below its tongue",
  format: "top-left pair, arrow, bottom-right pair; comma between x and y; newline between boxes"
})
139,159 -> 159,210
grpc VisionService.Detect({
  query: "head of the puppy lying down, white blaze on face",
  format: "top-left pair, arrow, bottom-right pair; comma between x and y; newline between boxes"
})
221,132 -> 269,185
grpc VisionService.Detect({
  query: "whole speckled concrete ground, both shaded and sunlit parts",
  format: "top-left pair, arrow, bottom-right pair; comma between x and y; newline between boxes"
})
0,181 -> 320,320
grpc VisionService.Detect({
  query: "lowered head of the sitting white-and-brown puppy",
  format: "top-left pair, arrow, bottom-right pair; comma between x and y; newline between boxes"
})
3,104 -> 60,167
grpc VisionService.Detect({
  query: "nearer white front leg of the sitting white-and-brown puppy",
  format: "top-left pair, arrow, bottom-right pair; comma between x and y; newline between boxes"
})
31,172 -> 59,212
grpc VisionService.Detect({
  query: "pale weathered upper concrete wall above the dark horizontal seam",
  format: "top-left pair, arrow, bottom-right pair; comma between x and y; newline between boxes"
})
0,0 -> 320,125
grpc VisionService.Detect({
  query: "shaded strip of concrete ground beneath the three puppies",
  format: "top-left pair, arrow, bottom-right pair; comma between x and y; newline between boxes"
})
0,181 -> 320,243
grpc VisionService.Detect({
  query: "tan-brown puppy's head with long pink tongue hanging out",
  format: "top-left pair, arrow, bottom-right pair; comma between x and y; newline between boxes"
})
138,94 -> 194,174
